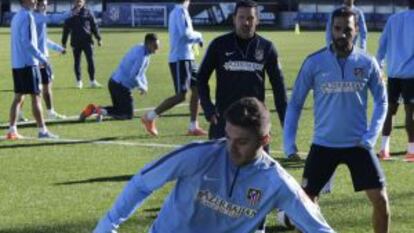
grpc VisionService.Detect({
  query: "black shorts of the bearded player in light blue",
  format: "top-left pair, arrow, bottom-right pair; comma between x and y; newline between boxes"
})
302,144 -> 385,196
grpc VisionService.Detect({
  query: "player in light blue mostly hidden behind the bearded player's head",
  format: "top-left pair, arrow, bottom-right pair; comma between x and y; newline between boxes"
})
326,0 -> 368,50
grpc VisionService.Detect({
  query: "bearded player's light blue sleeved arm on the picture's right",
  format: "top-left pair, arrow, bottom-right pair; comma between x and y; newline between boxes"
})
360,60 -> 388,149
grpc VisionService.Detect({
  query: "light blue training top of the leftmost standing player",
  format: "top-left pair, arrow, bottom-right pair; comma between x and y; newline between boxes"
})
11,8 -> 47,69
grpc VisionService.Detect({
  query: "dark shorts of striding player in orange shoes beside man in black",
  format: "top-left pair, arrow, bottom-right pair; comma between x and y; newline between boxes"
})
170,60 -> 198,94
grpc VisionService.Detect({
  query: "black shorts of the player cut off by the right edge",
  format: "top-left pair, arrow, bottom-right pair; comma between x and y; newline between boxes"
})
387,78 -> 414,104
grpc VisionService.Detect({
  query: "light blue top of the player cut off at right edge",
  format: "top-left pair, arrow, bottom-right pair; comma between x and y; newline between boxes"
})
377,10 -> 414,78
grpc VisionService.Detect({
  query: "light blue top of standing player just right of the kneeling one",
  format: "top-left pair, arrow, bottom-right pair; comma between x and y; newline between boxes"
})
168,4 -> 203,62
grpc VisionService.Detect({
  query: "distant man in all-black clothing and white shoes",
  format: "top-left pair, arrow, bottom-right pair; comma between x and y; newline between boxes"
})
62,0 -> 102,89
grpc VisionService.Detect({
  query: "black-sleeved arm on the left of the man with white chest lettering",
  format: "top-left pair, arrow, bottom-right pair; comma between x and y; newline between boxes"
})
197,40 -> 217,121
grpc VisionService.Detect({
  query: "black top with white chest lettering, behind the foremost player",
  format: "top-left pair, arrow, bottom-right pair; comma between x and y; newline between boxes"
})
197,32 -> 287,126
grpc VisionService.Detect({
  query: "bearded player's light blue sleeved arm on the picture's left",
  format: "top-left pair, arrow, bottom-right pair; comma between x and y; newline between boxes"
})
283,58 -> 313,156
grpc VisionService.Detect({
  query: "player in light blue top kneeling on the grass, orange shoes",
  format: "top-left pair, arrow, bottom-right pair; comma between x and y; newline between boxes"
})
79,33 -> 159,121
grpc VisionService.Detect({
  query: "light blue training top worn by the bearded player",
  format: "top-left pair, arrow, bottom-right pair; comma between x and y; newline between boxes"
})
284,46 -> 388,155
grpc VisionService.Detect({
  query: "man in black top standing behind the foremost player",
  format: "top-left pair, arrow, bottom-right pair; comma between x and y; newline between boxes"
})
198,0 -> 287,138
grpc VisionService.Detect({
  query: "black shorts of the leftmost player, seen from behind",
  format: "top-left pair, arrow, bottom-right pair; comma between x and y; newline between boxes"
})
12,66 -> 40,94
